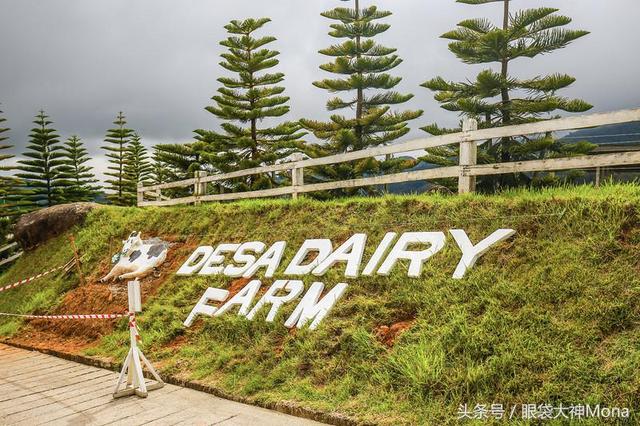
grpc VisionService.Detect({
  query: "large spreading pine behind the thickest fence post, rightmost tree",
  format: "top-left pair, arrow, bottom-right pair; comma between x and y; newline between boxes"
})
422,0 -> 593,190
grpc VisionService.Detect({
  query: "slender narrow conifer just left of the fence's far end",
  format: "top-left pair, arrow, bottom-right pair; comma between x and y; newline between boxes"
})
102,111 -> 133,206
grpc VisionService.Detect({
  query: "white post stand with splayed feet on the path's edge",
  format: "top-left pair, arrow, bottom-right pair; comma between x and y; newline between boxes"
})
113,280 -> 164,398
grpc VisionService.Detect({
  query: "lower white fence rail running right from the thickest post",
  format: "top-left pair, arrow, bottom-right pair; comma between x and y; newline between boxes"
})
463,152 -> 640,176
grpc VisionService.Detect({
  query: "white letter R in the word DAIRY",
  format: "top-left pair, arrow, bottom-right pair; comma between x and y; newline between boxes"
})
378,232 -> 446,278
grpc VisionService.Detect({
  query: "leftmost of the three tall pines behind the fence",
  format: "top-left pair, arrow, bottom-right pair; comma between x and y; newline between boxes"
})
192,18 -> 305,190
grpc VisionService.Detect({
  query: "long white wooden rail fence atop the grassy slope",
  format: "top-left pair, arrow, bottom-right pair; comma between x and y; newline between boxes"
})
138,109 -> 640,207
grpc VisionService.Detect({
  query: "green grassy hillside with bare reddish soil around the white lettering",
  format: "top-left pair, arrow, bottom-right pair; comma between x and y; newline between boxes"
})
0,185 -> 640,425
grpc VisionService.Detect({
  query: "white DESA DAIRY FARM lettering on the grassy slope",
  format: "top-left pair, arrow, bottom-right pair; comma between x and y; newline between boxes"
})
177,229 -> 515,330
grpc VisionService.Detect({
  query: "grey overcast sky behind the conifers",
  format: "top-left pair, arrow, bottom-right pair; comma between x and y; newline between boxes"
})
0,0 -> 640,180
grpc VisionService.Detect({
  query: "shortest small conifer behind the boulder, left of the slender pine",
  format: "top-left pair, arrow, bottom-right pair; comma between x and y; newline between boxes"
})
59,135 -> 98,203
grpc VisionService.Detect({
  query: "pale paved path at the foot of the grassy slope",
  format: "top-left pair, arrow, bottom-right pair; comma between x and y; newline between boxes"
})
0,344 -> 321,426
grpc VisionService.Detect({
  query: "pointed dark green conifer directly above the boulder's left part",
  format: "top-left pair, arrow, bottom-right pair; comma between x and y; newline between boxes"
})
15,111 -> 64,207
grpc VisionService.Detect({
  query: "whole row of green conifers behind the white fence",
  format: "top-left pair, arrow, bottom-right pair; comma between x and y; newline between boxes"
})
0,0 -> 593,236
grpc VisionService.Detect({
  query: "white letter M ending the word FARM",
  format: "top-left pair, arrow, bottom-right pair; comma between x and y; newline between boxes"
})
284,282 -> 347,330
